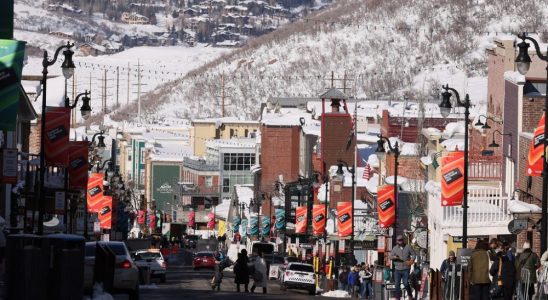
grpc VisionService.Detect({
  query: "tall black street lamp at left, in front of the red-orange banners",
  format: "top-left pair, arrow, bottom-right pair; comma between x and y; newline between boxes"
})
38,42 -> 74,235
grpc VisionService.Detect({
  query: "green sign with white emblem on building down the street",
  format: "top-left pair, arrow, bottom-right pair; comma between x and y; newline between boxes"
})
152,164 -> 181,211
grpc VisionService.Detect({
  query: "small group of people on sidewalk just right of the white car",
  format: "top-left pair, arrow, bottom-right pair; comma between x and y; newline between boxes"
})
338,262 -> 374,299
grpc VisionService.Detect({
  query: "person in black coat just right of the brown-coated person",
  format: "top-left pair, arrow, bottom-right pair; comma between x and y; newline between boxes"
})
489,248 -> 516,300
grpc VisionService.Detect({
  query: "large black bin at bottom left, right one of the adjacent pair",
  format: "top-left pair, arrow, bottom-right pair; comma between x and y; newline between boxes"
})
42,234 -> 85,300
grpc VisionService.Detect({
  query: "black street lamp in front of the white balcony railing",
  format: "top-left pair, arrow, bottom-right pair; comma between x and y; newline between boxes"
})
439,84 -> 471,248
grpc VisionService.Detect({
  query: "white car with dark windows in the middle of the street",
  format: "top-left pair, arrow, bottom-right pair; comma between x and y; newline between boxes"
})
280,263 -> 316,295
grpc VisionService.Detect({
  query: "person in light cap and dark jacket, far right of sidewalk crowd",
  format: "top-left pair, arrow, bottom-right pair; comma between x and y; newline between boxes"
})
515,242 -> 540,300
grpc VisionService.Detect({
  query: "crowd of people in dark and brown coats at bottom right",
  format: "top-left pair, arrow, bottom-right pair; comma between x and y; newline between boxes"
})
440,239 -> 548,300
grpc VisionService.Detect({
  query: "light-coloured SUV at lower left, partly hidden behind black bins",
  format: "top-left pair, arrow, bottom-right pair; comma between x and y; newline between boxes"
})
84,242 -> 139,300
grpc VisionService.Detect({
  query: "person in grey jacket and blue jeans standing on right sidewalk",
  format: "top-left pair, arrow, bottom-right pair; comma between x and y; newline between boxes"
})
390,235 -> 415,299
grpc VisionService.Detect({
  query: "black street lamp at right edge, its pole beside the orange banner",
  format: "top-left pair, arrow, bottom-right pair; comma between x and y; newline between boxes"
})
515,32 -> 548,253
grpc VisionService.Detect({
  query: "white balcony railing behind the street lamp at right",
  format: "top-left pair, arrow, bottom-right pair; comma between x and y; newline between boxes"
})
440,186 -> 512,226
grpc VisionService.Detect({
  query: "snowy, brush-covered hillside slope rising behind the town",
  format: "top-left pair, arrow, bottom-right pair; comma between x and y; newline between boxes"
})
130,0 -> 548,118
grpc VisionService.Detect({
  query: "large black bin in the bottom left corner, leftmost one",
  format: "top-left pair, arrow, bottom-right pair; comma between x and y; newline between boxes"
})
5,234 -> 48,300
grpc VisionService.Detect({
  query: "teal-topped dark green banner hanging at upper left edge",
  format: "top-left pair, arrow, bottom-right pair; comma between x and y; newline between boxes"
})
0,40 -> 26,131
